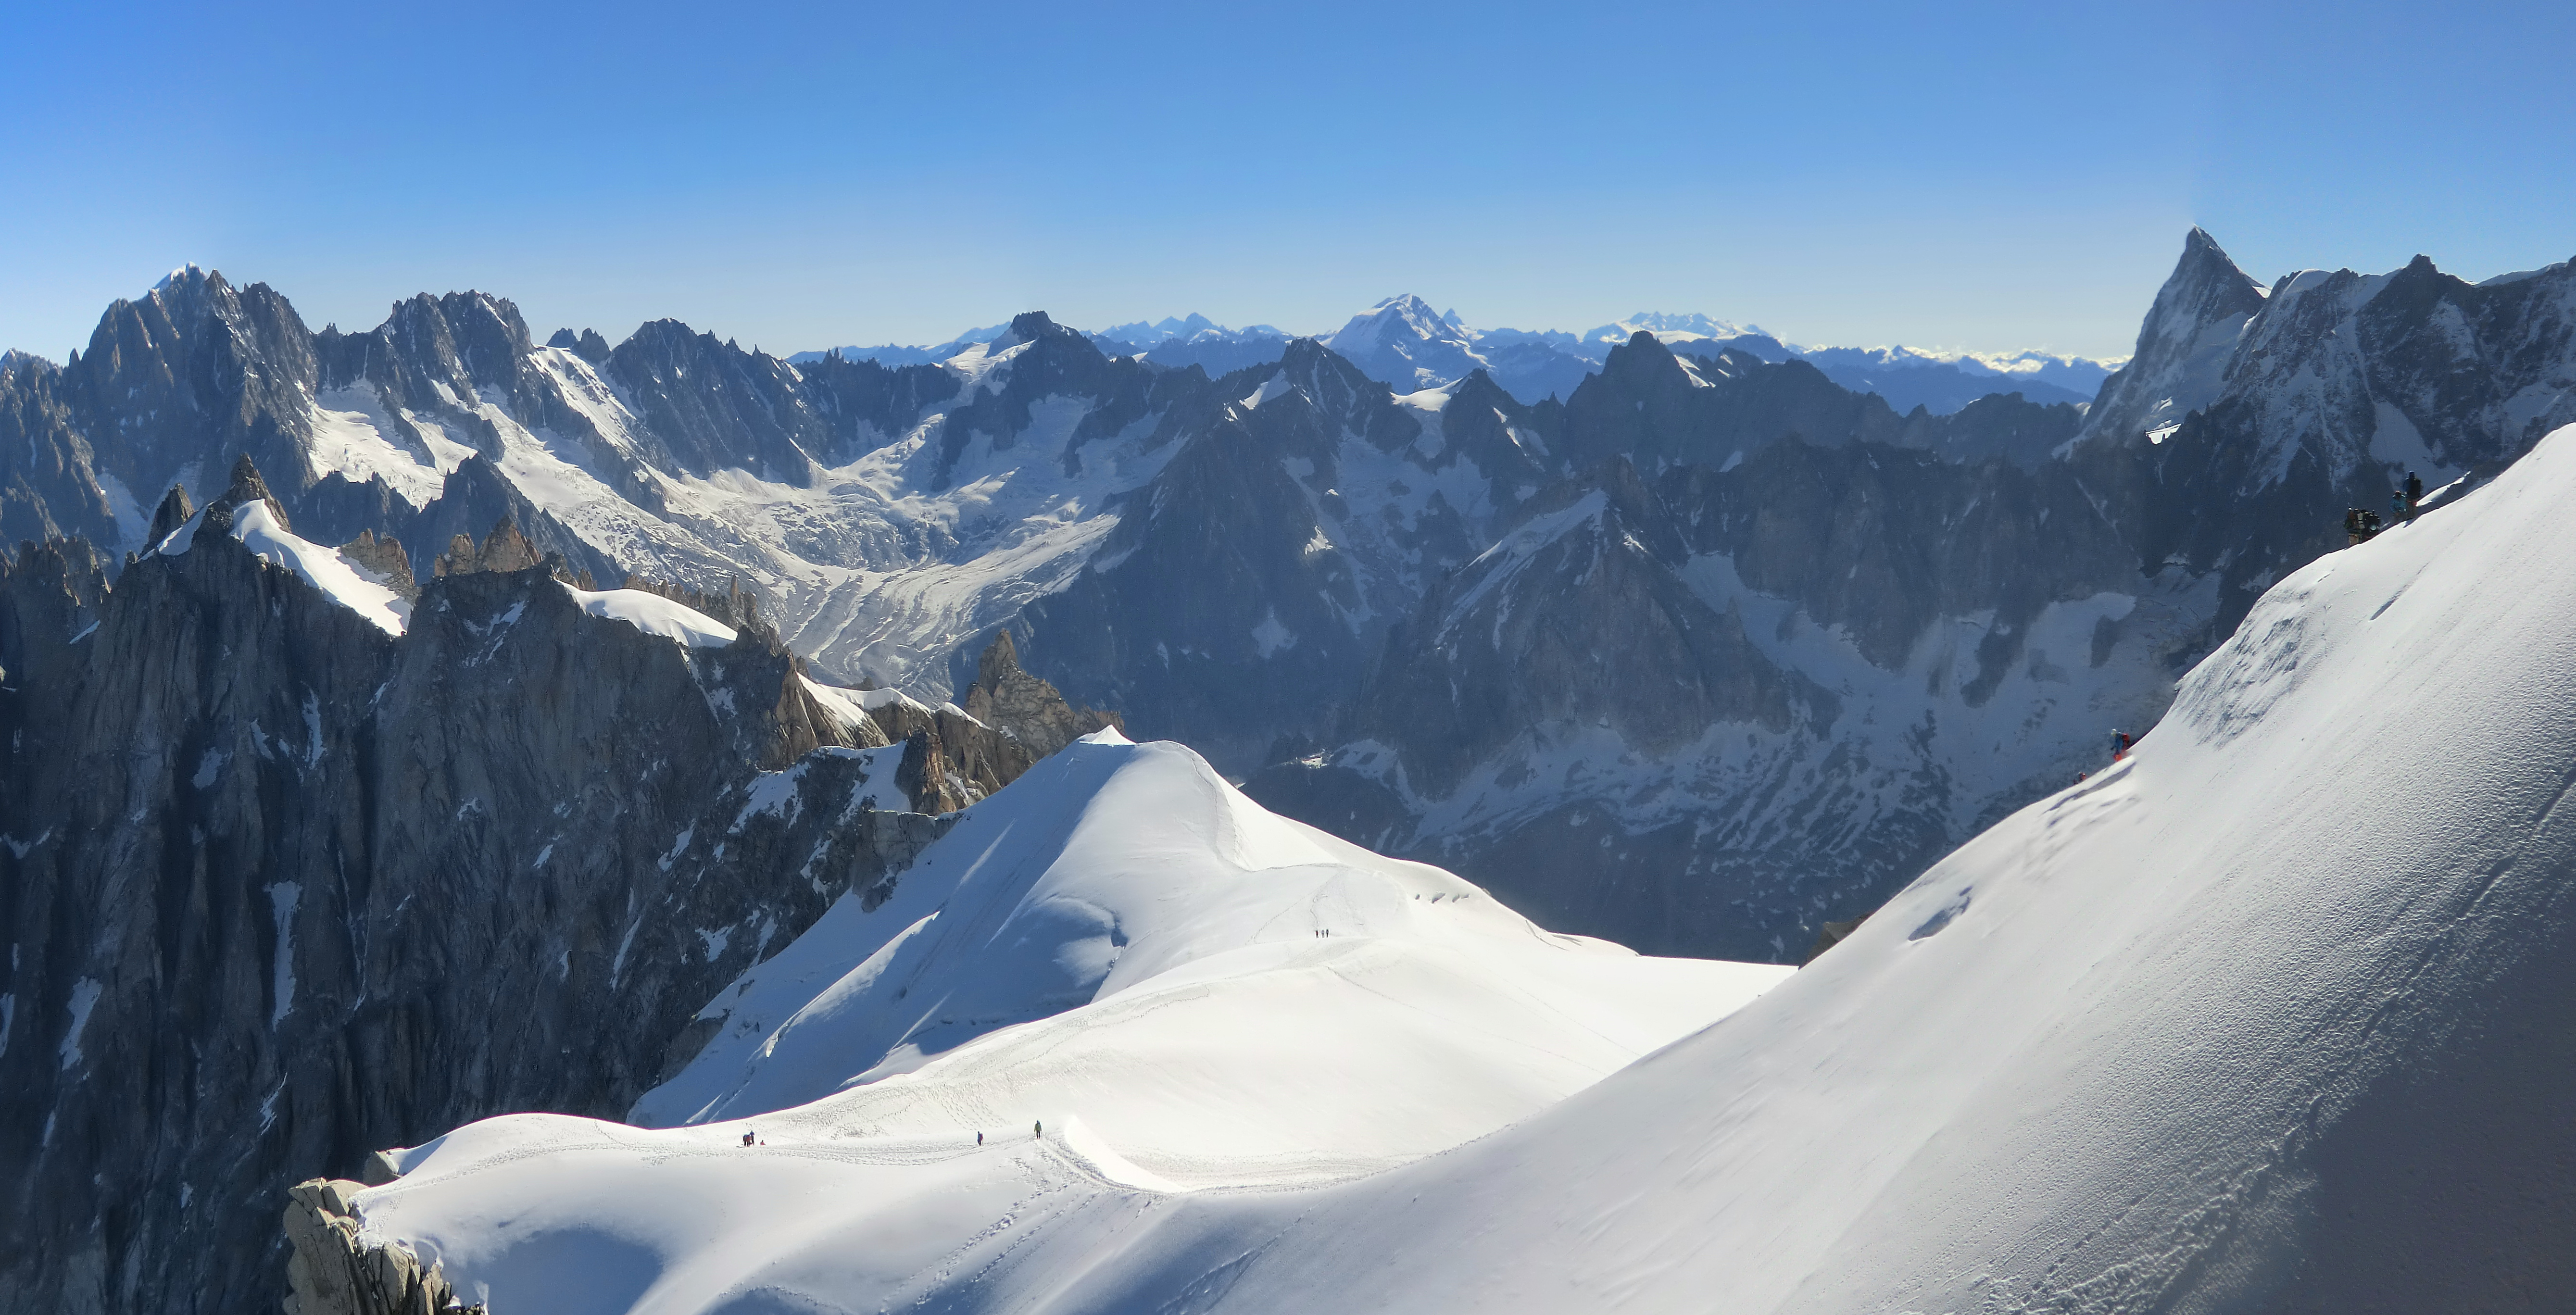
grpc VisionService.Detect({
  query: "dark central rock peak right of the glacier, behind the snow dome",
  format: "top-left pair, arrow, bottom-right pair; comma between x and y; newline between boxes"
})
1023,339 -> 1494,762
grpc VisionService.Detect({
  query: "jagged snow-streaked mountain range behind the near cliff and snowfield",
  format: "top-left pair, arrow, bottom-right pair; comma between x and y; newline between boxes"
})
0,234 -> 2576,977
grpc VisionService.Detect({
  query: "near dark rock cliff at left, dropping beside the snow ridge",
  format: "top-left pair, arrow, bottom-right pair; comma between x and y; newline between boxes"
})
0,471 -> 968,1310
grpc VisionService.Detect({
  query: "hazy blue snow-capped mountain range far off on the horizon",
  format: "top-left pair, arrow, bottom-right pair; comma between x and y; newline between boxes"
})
788,293 -> 2120,414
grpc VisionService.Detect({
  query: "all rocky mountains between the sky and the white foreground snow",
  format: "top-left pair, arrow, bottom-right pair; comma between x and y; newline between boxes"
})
0,232 -> 2576,1310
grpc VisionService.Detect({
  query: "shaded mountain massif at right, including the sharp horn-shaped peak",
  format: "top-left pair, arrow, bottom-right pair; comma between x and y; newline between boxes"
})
1247,232 -> 2576,957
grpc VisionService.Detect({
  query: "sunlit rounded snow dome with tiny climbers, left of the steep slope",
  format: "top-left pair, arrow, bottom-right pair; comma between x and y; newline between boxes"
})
366,731 -> 1788,1313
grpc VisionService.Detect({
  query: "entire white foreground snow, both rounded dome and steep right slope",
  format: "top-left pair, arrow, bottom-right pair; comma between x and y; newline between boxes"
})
342,430 -> 2576,1315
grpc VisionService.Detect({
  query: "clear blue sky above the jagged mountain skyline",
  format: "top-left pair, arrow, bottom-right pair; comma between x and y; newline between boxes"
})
0,0 -> 2576,360
